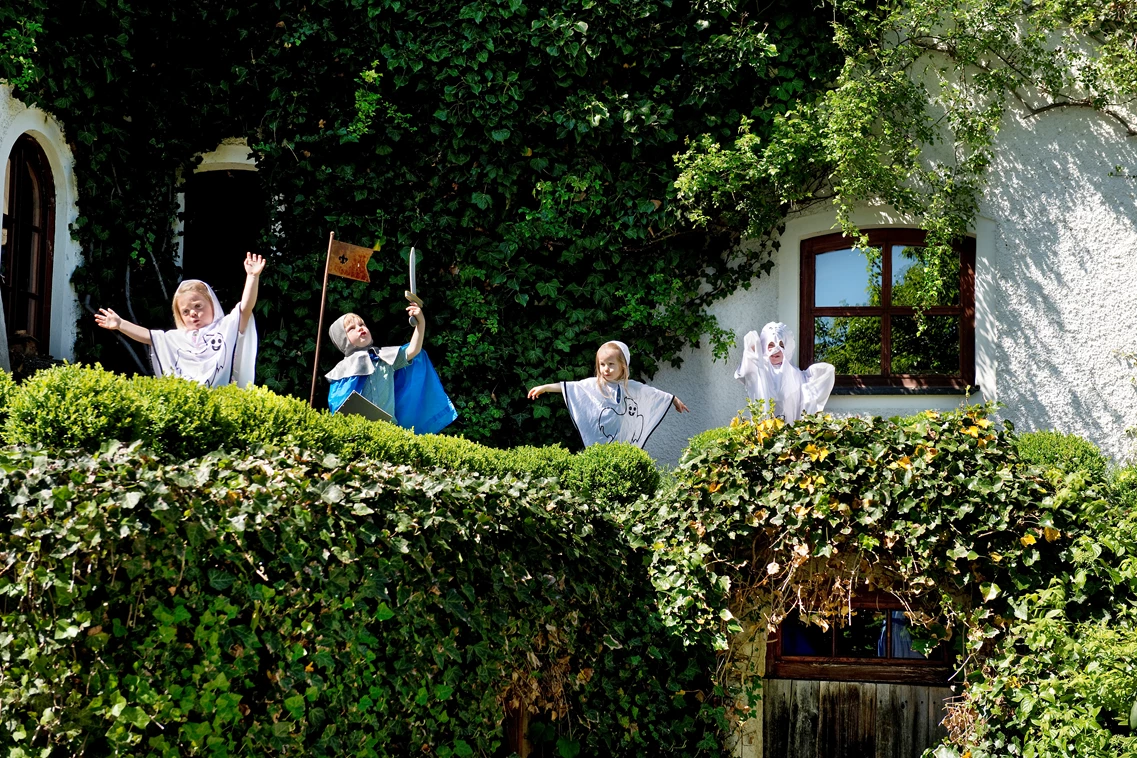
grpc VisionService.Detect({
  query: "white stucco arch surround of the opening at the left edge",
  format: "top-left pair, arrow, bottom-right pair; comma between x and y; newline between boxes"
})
0,82 -> 82,360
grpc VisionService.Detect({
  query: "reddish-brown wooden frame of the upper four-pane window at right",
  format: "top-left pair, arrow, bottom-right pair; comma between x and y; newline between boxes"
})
800,228 -> 976,391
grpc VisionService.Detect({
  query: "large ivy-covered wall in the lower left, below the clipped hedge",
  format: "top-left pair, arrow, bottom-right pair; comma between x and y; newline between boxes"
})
0,447 -> 721,757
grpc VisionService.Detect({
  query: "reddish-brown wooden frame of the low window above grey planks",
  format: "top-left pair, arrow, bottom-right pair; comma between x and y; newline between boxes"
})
766,592 -> 955,686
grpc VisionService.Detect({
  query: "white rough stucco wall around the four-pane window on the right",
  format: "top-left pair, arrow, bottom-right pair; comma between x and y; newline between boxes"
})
647,101 -> 1137,464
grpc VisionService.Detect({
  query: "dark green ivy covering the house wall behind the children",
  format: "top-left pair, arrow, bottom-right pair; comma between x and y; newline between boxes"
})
0,0 -> 837,443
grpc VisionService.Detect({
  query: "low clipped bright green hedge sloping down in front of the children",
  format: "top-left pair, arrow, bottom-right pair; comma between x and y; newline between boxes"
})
0,365 -> 659,503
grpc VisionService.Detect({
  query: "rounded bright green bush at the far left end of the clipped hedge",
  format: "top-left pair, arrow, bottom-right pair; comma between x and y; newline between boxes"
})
6,364 -> 144,450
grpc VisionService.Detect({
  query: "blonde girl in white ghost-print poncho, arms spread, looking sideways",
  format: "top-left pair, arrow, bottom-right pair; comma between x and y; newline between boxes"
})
529,342 -> 687,448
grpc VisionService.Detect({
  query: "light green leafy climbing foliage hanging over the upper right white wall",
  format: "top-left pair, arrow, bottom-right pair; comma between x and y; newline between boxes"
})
678,0 -> 1137,305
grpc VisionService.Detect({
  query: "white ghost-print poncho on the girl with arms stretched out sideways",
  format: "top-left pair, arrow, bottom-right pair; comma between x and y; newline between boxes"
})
561,376 -> 675,448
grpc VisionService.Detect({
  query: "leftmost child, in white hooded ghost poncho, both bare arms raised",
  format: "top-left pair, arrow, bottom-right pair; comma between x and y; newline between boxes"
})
94,252 -> 265,386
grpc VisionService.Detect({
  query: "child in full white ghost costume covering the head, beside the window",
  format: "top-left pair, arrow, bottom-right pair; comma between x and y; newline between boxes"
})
735,322 -> 836,424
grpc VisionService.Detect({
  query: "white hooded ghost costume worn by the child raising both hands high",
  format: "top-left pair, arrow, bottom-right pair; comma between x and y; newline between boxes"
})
150,280 -> 257,386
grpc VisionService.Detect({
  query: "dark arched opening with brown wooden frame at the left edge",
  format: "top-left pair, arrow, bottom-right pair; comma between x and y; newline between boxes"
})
0,134 -> 56,355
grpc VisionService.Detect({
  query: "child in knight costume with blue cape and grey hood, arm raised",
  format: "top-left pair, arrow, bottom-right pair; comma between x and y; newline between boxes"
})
324,302 -> 458,434
